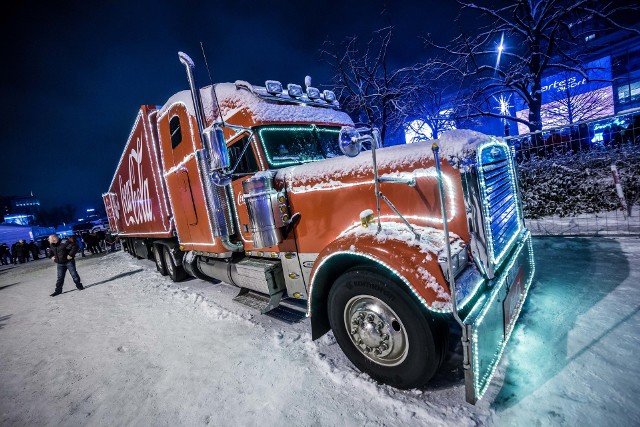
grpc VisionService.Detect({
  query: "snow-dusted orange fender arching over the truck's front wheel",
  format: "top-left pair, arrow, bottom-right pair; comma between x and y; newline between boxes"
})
307,222 -> 462,339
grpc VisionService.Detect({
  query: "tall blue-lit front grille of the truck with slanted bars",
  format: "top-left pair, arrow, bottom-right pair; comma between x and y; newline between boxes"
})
478,144 -> 522,267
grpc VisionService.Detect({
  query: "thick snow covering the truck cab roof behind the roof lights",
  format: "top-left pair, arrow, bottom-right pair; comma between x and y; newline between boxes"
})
159,82 -> 353,125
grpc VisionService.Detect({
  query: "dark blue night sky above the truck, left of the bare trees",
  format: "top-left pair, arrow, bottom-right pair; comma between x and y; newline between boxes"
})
0,0 -> 470,214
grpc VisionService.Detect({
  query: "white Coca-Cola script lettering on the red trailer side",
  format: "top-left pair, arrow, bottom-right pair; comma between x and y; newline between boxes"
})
118,138 -> 153,225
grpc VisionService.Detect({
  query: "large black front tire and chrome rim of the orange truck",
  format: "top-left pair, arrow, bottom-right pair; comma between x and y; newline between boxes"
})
328,267 -> 444,389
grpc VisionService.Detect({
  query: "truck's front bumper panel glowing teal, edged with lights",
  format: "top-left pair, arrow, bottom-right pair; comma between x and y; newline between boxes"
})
462,232 -> 534,404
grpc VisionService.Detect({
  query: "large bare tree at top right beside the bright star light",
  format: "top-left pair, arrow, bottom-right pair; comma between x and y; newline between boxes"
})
429,0 -> 640,132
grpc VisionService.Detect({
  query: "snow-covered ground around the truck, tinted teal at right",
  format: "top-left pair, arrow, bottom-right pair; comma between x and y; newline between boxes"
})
0,238 -> 640,426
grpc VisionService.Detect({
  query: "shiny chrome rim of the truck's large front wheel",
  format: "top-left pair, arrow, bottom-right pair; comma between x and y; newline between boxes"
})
344,295 -> 409,366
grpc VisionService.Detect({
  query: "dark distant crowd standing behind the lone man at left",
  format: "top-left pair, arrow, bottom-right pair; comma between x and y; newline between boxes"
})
0,230 -> 118,265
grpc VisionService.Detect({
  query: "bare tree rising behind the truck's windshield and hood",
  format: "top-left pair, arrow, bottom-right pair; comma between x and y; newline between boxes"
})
321,27 -> 424,145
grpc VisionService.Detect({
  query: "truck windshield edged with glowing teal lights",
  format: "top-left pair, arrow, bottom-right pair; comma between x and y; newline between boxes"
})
257,125 -> 342,168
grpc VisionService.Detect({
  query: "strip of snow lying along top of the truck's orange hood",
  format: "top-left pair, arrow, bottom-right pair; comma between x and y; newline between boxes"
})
278,130 -> 491,188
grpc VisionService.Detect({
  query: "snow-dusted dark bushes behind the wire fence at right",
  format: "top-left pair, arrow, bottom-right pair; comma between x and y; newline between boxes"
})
518,145 -> 640,219
